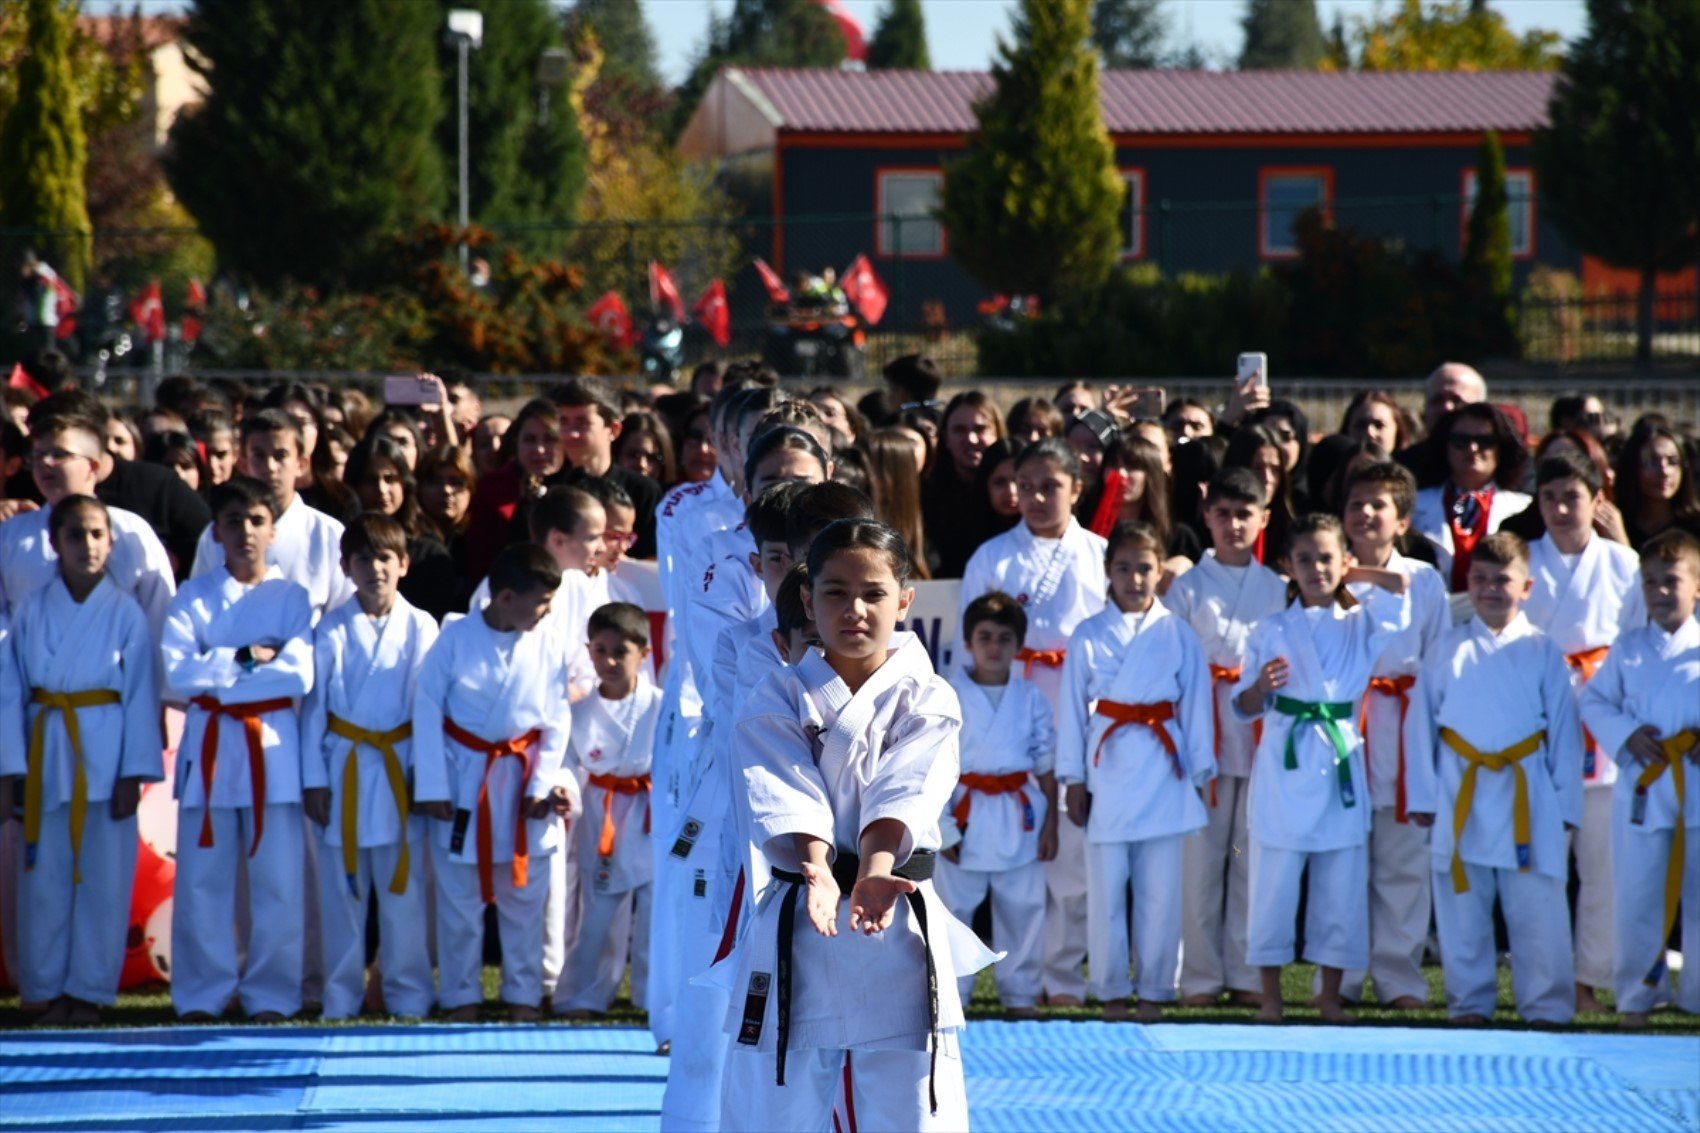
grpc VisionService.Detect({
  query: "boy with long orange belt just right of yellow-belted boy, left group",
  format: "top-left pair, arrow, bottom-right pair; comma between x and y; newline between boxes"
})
413,543 -> 580,1022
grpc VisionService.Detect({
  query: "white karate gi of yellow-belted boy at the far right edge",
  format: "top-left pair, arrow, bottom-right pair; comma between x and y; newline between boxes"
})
1581,618 -> 1700,1014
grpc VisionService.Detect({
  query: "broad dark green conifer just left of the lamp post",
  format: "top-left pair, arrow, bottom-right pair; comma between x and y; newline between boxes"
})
167,0 -> 444,286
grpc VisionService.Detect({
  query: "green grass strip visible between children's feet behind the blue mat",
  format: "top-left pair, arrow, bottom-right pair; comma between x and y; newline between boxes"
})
0,965 -> 1700,1034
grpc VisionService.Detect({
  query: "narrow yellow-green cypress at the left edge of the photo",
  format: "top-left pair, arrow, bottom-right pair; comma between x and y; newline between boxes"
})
0,0 -> 90,291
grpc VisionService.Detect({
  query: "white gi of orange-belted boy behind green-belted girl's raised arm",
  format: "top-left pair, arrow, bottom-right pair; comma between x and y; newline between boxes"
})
1339,551 -> 1452,1004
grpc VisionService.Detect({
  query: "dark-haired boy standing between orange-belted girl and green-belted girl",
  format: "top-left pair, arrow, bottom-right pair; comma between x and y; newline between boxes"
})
1163,468 -> 1287,1005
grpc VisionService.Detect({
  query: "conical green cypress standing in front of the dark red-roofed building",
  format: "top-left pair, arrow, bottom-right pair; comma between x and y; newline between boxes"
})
940,0 -> 1124,305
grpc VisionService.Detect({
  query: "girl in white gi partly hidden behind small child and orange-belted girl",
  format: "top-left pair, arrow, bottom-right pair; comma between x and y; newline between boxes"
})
962,437 -> 1107,1005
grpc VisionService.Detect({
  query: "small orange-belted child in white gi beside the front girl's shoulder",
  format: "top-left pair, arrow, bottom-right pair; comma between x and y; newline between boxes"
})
933,590 -> 1057,1019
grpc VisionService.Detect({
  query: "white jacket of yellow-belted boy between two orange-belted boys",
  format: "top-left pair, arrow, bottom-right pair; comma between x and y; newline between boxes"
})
301,594 -> 437,849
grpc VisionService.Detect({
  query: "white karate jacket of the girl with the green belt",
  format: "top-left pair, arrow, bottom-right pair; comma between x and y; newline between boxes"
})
1234,587 -> 1426,852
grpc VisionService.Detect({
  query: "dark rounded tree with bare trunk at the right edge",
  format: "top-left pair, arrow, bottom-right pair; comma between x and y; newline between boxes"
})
1533,0 -> 1700,367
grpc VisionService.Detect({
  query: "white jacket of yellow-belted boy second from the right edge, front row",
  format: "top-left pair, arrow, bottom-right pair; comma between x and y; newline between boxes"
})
1406,612 -> 1583,880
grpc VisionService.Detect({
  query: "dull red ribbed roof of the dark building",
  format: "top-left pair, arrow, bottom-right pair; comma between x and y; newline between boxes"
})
723,68 -> 1556,134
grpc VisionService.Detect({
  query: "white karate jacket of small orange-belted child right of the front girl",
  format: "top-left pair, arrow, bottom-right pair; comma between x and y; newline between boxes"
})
940,670 -> 1056,873
